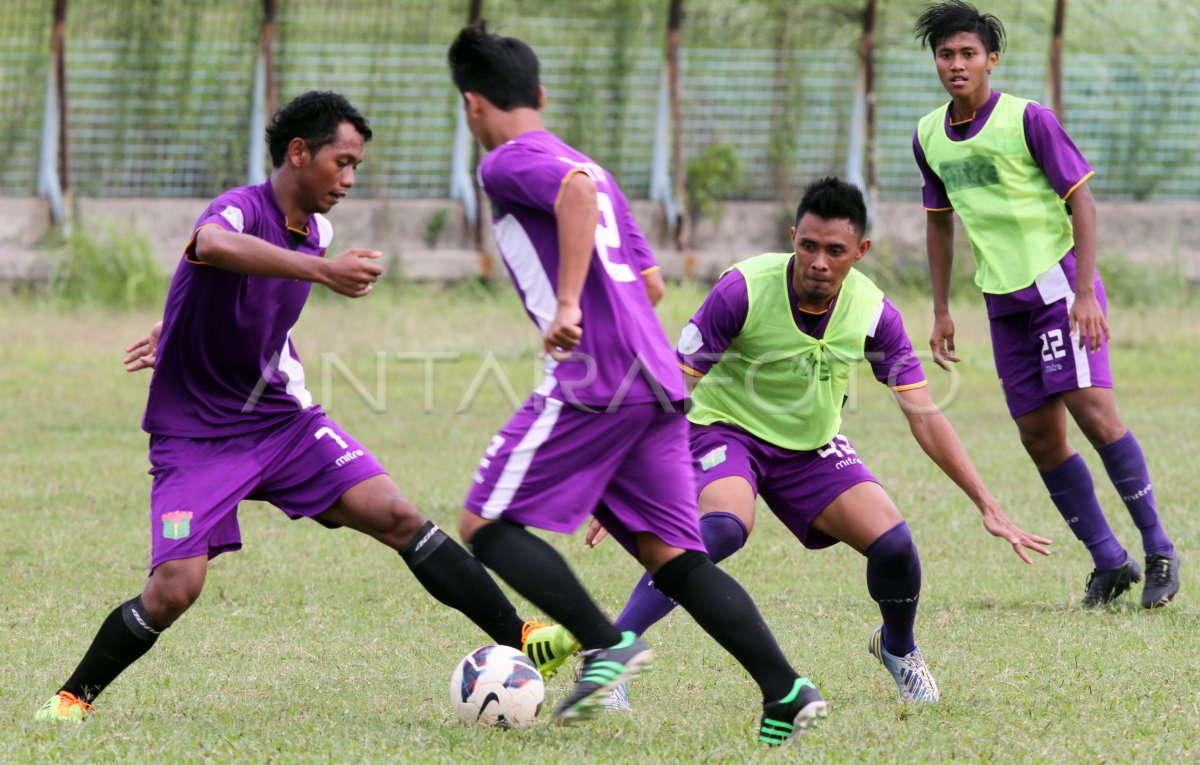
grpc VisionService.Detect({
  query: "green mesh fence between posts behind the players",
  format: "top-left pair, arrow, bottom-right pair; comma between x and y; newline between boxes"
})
7,0 -> 1200,200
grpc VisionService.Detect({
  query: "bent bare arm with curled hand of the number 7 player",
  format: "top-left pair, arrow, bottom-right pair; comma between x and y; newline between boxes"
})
194,225 -> 383,297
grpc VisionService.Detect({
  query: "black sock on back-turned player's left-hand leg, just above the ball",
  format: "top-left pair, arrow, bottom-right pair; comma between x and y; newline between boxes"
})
470,520 -> 620,649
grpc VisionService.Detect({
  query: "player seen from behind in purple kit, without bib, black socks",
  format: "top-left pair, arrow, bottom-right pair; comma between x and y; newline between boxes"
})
449,25 -> 826,745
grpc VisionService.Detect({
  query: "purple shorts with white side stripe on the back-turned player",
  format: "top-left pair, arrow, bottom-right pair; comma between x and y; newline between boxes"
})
463,393 -> 704,552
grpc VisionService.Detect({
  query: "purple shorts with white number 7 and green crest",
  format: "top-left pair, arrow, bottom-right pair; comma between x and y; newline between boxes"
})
150,408 -> 386,571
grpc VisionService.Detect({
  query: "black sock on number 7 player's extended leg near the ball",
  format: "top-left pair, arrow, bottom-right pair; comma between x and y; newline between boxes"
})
400,520 -> 523,651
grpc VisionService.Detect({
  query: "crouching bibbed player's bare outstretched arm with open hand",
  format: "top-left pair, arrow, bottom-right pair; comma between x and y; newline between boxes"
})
895,387 -> 1050,564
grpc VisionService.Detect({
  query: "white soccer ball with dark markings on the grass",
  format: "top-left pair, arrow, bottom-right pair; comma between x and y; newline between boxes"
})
450,645 -> 546,728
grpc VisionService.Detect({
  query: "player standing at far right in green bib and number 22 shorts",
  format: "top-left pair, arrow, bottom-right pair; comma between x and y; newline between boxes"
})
913,0 -> 1180,608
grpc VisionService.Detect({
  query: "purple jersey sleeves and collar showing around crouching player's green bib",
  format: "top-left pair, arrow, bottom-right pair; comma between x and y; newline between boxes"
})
677,259 -> 926,391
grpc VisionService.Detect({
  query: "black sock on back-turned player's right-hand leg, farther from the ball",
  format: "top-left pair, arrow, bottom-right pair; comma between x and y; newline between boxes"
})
654,550 -> 797,701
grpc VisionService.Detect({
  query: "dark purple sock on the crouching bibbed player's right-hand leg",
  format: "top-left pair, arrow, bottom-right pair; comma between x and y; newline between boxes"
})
863,520 -> 920,656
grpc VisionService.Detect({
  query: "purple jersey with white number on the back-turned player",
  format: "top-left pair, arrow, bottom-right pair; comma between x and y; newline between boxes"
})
479,131 -> 686,408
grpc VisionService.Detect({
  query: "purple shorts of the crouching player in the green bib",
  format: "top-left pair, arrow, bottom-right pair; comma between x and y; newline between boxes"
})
691,422 -> 878,549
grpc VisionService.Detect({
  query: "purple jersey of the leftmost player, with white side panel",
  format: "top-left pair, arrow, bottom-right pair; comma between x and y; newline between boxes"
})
142,181 -> 332,438
